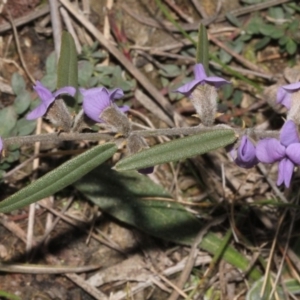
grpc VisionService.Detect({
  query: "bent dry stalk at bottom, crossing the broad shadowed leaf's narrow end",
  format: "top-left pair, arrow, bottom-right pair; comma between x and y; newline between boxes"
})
168,217 -> 225,300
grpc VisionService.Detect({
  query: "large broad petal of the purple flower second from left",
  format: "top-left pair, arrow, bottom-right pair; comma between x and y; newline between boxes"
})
79,87 -> 111,123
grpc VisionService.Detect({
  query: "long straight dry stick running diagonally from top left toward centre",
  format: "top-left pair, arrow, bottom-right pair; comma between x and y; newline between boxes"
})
60,0 -> 175,126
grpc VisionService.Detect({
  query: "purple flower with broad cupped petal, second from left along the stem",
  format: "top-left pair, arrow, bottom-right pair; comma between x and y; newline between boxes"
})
79,87 -> 129,123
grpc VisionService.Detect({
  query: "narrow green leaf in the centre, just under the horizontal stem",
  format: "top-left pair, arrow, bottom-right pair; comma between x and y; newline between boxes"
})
115,129 -> 236,171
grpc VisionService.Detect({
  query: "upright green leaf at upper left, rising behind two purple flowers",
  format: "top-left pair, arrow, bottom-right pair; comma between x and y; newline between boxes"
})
57,31 -> 78,89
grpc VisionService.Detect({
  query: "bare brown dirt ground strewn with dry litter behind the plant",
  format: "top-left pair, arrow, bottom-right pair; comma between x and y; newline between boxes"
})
0,0 -> 298,300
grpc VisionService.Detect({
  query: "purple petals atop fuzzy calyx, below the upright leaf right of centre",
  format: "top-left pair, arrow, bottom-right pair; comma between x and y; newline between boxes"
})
176,64 -> 230,97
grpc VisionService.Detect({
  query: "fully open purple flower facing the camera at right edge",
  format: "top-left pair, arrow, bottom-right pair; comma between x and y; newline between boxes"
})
256,121 -> 300,188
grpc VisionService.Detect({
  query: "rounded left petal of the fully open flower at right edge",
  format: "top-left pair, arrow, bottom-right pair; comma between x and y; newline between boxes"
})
256,138 -> 285,164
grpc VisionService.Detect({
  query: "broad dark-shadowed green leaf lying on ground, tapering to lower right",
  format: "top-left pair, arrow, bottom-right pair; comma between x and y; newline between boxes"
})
74,165 -> 261,280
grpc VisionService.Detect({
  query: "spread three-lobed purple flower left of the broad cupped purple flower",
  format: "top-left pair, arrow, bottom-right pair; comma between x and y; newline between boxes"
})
26,81 -> 76,120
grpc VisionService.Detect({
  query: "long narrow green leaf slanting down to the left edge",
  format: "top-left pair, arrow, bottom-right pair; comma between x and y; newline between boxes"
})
0,143 -> 117,213
